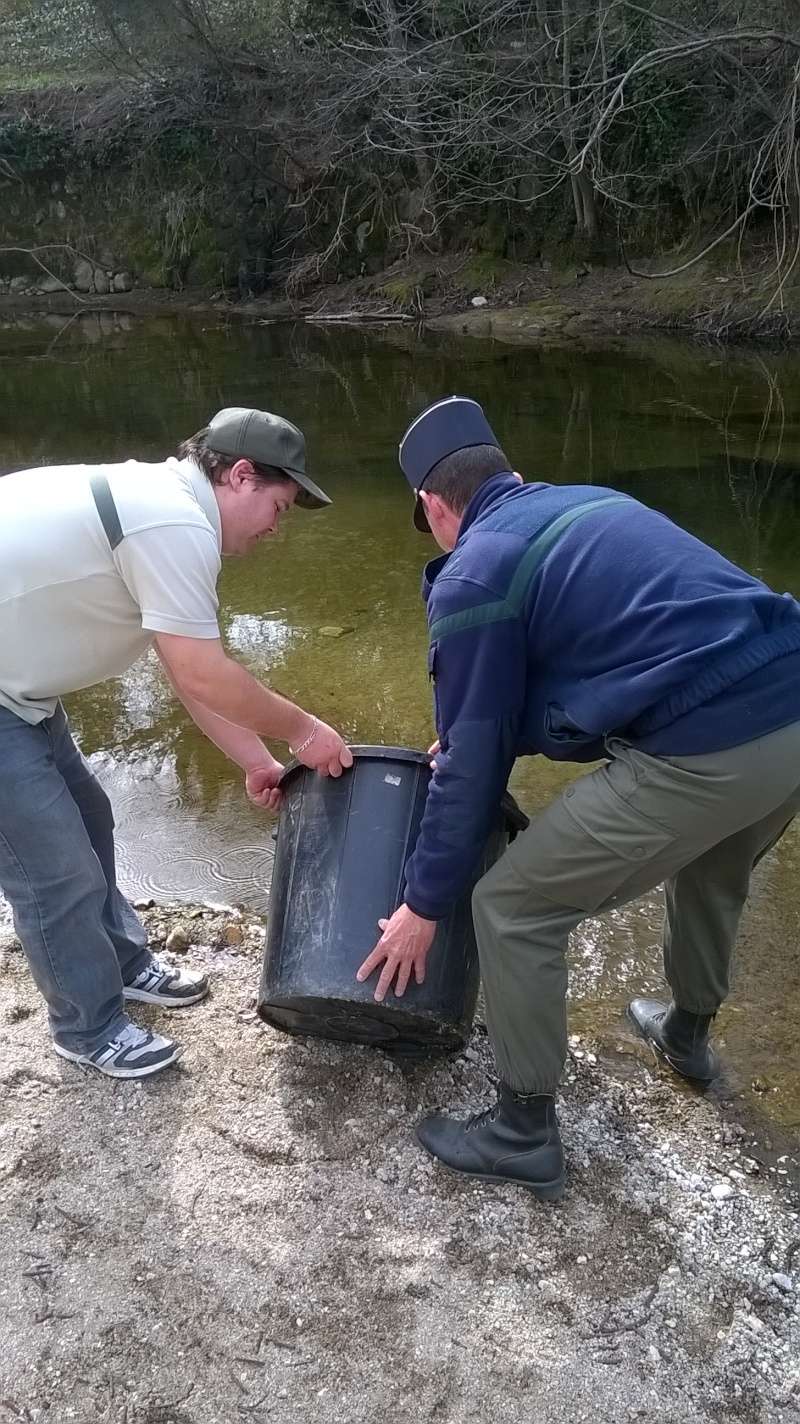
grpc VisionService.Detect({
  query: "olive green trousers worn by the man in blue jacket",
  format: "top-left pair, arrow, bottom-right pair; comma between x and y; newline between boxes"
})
473,722 -> 800,1092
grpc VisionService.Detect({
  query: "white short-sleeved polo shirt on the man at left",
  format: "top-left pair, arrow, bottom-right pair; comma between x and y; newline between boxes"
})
0,460 -> 222,723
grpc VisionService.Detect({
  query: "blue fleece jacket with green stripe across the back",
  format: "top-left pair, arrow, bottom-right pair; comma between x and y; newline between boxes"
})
406,473 -> 800,920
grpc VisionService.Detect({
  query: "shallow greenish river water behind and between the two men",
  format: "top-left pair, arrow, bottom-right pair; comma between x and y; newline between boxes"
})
0,313 -> 800,1126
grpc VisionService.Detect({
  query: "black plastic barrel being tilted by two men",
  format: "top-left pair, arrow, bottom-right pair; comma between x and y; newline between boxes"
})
258,746 -> 527,1054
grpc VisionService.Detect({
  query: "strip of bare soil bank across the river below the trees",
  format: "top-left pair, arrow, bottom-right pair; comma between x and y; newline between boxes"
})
6,252 -> 800,345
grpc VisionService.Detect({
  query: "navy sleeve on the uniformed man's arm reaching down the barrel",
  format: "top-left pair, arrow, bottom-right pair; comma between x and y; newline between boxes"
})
406,615 -> 527,920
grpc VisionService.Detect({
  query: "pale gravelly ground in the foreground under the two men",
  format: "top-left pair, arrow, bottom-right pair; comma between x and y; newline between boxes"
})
0,906 -> 800,1424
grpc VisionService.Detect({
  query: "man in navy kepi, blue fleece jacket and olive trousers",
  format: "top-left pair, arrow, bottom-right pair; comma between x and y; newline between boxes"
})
359,396 -> 800,1198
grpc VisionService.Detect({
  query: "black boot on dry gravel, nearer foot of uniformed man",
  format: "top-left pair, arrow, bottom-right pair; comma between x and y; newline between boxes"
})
417,1084 -> 564,1200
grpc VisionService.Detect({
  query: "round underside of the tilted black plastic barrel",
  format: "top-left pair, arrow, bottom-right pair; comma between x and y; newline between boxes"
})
258,995 -> 467,1061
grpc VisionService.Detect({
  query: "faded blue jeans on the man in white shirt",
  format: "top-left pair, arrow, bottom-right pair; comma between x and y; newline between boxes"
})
0,705 -> 151,1054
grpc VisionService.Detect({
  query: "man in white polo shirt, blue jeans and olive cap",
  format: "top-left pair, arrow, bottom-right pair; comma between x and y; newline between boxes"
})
0,407 -> 352,1078
